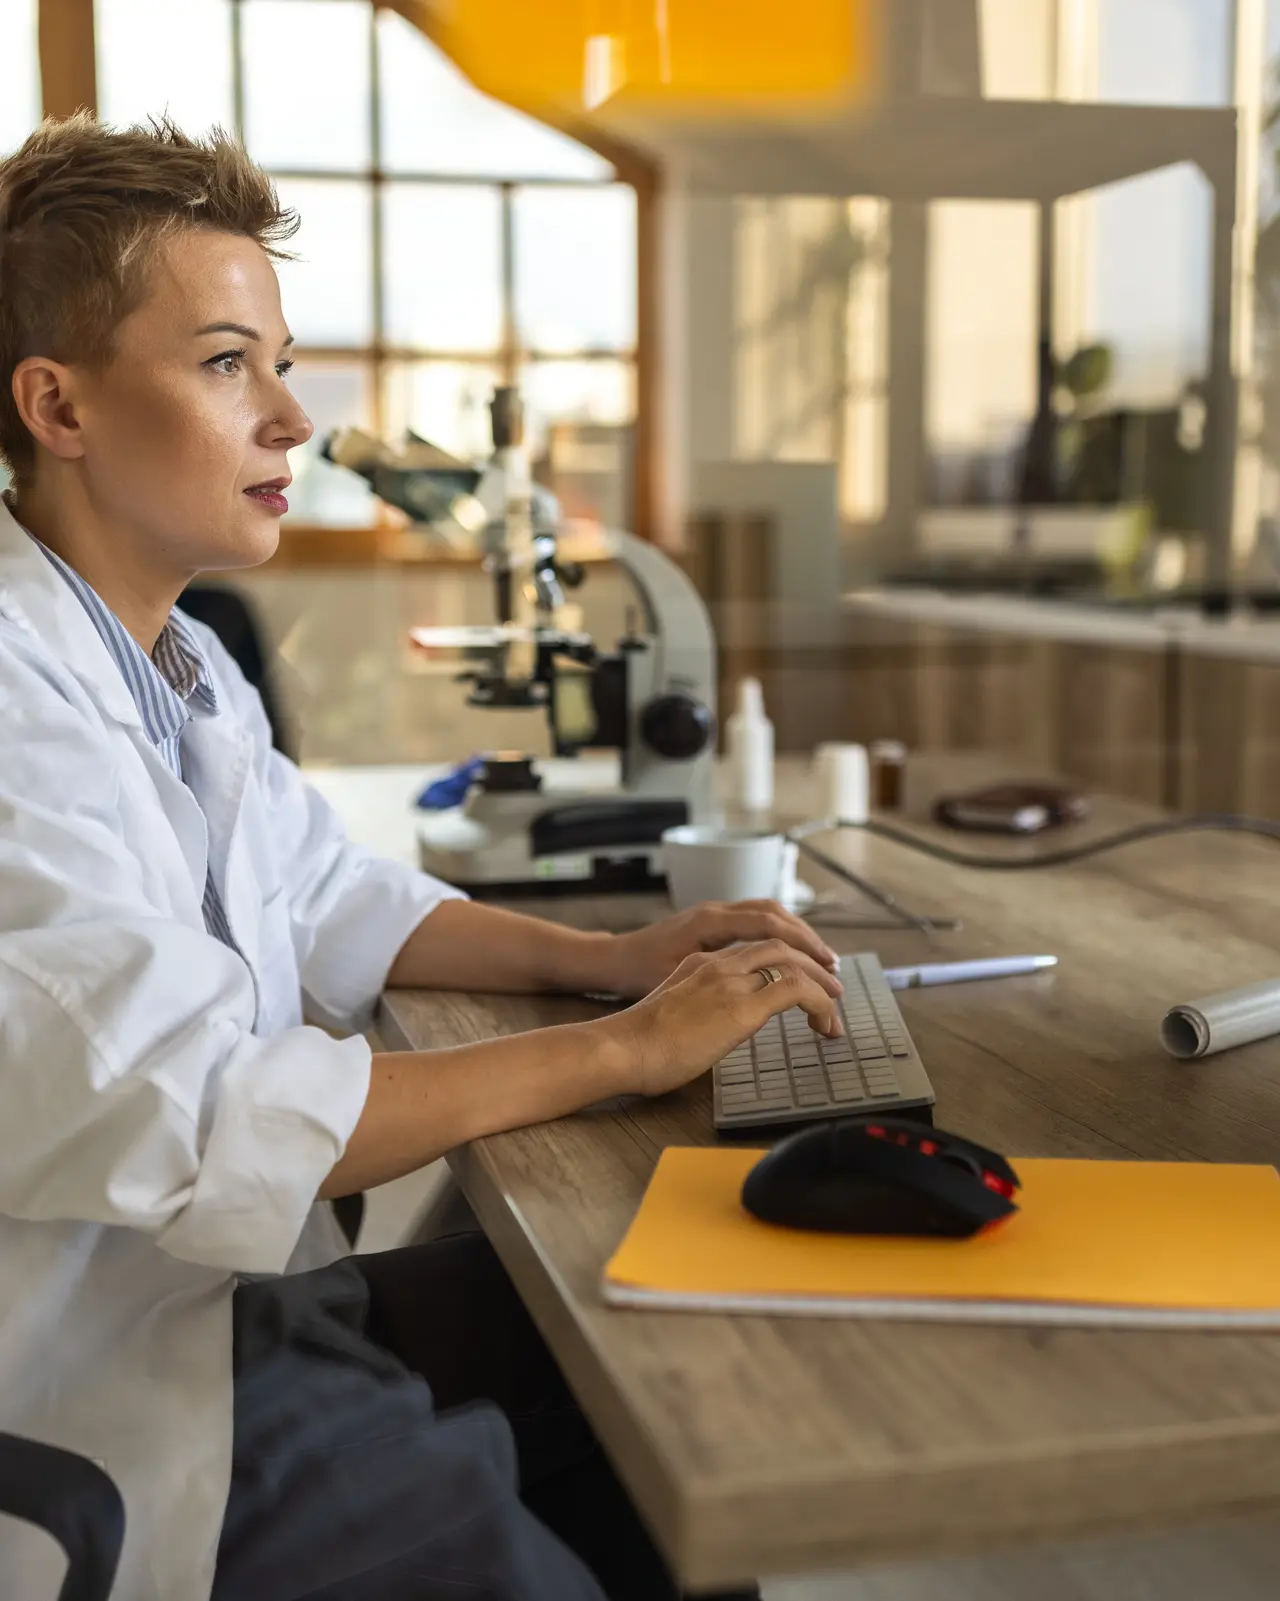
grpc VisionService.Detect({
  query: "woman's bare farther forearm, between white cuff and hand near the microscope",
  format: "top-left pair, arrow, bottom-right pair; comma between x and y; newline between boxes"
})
387,901 -> 613,994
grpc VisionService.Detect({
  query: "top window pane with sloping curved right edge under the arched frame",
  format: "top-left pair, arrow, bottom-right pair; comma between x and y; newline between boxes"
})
378,10 -> 613,178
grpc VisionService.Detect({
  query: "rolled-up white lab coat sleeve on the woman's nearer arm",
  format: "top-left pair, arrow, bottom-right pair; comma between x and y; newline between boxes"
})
0,640 -> 370,1271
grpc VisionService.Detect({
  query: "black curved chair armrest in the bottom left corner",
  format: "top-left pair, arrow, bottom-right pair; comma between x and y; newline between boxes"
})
0,1434 -> 125,1601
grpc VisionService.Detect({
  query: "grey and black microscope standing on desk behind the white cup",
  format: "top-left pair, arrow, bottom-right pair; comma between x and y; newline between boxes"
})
323,387 -> 718,897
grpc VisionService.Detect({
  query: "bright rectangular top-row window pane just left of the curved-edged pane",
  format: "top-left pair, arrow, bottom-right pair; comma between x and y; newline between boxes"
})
242,0 -> 370,173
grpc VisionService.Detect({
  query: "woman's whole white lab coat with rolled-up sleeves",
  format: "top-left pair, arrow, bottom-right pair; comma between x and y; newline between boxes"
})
0,503 -> 456,1601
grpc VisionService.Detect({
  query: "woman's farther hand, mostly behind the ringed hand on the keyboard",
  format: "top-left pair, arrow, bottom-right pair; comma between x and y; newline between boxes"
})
592,901 -> 838,999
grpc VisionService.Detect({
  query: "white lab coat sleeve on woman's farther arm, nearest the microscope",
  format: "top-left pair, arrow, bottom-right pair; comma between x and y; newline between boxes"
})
202,634 -> 466,1029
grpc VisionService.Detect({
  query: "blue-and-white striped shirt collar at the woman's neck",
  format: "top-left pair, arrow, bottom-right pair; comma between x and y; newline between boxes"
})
30,535 -> 218,742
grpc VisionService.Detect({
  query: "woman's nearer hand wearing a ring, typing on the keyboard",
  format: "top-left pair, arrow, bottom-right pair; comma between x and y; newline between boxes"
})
597,940 -> 843,1095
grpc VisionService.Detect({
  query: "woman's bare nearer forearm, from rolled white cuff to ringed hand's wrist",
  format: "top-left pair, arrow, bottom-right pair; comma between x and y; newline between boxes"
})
320,1023 -> 635,1199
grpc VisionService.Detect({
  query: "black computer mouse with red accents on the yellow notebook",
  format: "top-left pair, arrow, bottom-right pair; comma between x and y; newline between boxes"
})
742,1116 -> 1019,1239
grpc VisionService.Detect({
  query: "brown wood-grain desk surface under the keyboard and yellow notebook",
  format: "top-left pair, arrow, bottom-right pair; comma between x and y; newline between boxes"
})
379,762 -> 1280,1588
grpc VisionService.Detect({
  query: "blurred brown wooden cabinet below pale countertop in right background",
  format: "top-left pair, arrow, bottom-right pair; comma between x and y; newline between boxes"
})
832,616 -> 1280,818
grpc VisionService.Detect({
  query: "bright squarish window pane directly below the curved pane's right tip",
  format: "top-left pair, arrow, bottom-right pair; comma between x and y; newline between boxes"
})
515,184 -> 635,351
